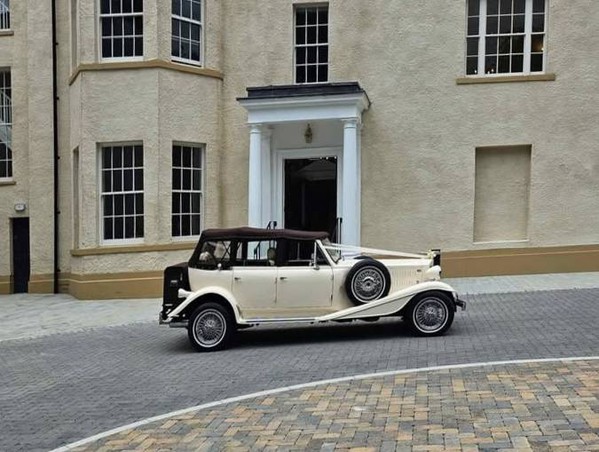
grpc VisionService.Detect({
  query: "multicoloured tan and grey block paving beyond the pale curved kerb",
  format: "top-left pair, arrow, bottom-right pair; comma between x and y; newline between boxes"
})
75,360 -> 599,452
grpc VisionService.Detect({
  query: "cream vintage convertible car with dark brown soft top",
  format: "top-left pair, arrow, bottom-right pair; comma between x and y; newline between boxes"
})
159,227 -> 466,351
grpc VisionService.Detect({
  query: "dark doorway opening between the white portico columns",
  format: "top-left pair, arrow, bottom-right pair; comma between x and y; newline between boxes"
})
285,157 -> 337,234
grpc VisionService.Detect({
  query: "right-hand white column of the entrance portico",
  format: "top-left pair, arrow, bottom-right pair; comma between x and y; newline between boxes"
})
341,118 -> 360,246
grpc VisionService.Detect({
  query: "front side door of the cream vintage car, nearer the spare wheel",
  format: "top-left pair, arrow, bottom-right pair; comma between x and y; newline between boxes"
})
277,241 -> 333,310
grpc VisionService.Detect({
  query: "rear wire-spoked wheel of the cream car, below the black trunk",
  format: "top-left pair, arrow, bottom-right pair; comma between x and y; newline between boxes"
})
187,303 -> 235,352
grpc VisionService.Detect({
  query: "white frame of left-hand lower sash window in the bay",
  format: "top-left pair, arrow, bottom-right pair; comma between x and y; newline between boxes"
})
97,141 -> 146,246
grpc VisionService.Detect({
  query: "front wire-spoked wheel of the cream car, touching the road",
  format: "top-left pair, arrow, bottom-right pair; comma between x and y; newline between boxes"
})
404,292 -> 454,336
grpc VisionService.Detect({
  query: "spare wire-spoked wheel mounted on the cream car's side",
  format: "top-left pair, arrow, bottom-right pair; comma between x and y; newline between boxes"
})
345,259 -> 391,304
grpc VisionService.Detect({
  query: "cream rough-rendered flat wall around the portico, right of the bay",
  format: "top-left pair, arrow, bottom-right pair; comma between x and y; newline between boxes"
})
223,0 -> 599,254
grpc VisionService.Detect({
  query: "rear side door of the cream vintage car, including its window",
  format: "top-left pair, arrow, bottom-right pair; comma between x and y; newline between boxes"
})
232,241 -> 277,315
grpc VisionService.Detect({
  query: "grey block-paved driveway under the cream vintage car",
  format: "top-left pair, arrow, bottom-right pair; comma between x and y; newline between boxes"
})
0,289 -> 599,451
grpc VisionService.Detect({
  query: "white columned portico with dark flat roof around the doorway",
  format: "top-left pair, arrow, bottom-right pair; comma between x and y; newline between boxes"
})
238,82 -> 369,245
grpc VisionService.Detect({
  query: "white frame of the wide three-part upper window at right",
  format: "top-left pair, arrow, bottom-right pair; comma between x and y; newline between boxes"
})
463,0 -> 549,78
